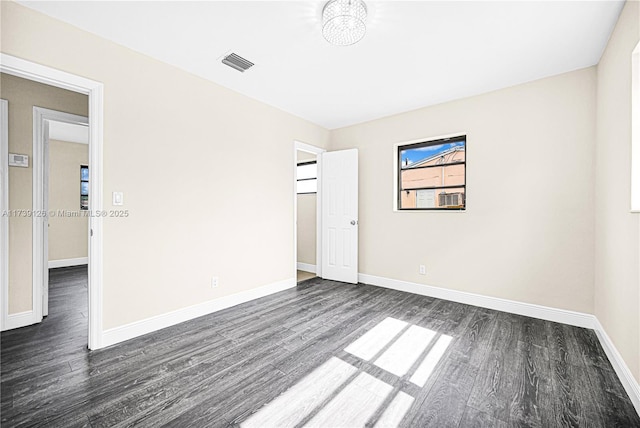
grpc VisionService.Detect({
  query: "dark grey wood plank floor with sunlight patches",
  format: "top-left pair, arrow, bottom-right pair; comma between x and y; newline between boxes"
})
0,267 -> 640,428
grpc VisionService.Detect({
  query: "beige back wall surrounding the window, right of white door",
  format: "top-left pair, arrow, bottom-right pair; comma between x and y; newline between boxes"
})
330,67 -> 596,312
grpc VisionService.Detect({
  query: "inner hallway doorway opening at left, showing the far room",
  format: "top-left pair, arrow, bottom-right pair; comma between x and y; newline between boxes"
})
39,112 -> 90,316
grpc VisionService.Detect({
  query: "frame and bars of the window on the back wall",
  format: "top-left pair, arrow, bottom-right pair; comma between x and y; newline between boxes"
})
394,133 -> 468,212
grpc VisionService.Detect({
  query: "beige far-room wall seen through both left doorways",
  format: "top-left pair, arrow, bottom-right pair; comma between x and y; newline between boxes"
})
49,140 -> 89,260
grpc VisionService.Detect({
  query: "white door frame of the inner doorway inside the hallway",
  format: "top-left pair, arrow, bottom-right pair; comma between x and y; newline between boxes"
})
32,106 -> 91,318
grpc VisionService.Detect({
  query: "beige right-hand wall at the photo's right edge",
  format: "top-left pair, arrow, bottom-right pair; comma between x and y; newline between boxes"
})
595,1 -> 640,381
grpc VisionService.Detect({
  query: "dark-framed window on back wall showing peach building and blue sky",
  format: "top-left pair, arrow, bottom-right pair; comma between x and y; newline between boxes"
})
397,135 -> 467,210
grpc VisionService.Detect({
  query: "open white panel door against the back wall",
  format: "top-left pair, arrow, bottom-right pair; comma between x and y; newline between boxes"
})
320,149 -> 358,284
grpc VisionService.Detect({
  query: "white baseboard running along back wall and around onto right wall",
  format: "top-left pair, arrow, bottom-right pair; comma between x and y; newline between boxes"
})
358,273 -> 640,415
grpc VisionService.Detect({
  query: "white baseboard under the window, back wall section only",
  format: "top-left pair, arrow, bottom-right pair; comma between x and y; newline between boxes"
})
358,273 -> 595,328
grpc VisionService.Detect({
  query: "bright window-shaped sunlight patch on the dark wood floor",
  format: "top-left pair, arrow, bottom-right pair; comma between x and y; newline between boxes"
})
241,317 -> 453,428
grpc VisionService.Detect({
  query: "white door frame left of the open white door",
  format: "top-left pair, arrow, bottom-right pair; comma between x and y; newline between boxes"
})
293,141 -> 326,280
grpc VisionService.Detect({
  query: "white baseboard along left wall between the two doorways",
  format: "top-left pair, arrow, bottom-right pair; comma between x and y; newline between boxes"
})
102,278 -> 296,346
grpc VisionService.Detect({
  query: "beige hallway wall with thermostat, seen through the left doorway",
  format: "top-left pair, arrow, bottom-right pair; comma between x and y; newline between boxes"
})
0,72 -> 88,314
